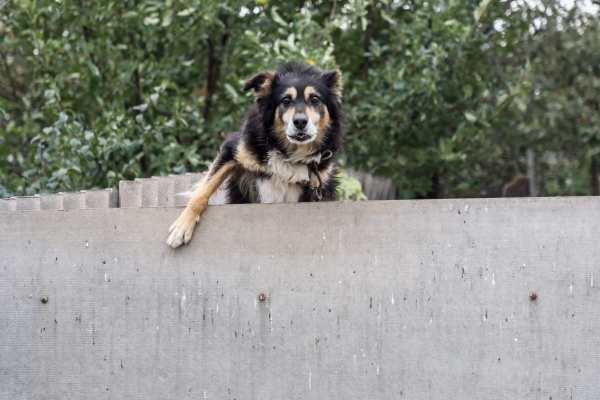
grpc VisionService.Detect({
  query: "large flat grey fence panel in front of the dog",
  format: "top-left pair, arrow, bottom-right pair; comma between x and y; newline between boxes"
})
0,198 -> 600,399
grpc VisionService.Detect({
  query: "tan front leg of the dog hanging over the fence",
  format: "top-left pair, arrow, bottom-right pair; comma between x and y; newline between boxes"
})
167,160 -> 237,248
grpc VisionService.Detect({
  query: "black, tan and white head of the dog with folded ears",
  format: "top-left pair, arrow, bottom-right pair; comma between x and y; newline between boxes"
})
244,64 -> 342,145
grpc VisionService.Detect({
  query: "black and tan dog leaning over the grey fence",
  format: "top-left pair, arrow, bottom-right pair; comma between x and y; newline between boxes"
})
167,64 -> 342,248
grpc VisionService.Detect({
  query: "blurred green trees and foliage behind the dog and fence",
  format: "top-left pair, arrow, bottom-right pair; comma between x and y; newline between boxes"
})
0,0 -> 600,198
